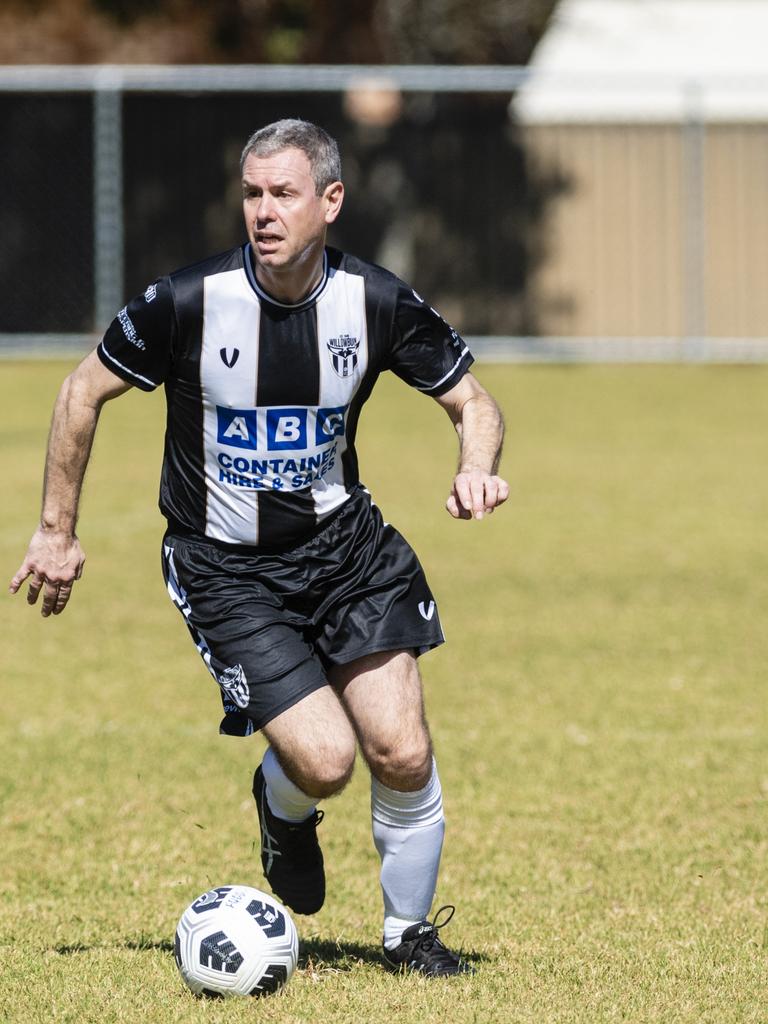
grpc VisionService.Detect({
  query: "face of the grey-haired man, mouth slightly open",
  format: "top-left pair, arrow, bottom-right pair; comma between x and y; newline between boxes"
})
243,148 -> 344,275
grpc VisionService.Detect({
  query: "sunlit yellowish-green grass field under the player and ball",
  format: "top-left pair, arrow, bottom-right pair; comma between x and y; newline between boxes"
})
0,362 -> 768,1024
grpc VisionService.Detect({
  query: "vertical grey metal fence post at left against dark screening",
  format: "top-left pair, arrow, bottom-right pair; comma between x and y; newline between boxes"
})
93,68 -> 124,332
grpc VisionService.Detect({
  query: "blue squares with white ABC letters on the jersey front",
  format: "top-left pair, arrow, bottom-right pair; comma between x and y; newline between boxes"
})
216,406 -> 347,452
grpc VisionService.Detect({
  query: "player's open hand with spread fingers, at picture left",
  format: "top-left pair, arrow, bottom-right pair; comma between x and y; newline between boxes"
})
8,526 -> 85,618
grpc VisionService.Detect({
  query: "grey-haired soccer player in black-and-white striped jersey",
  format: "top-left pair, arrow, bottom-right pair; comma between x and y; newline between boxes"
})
10,120 -> 509,977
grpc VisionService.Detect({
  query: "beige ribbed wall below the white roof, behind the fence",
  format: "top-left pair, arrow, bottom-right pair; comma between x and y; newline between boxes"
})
525,125 -> 768,337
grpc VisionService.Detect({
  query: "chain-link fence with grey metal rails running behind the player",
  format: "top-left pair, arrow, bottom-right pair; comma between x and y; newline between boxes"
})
0,67 -> 768,361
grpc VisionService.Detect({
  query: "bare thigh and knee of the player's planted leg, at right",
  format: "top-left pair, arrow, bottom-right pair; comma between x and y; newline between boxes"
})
329,650 -> 432,792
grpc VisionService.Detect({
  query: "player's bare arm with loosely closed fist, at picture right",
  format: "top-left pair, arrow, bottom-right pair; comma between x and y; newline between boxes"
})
435,373 -> 509,519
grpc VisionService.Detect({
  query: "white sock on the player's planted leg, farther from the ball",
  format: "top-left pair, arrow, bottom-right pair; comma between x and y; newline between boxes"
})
371,761 -> 445,949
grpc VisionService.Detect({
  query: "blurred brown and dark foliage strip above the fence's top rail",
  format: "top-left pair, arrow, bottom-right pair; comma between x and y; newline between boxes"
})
0,0 -> 556,65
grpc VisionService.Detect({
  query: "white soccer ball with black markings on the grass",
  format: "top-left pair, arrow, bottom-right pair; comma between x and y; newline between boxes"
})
174,886 -> 299,996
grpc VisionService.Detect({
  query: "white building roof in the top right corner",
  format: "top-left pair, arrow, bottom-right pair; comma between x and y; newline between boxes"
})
512,0 -> 768,123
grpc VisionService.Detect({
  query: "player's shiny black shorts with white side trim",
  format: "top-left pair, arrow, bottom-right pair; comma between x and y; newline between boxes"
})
163,487 -> 443,736
